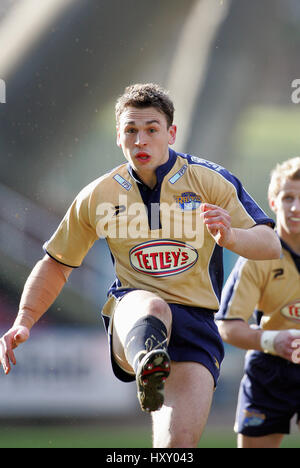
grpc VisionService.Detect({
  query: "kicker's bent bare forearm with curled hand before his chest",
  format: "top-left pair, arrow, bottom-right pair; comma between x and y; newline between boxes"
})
201,203 -> 281,260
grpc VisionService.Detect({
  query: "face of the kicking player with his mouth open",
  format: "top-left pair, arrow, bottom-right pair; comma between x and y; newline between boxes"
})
117,107 -> 176,183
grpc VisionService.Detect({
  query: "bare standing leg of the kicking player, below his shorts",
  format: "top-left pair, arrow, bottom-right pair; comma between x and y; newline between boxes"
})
152,361 -> 214,448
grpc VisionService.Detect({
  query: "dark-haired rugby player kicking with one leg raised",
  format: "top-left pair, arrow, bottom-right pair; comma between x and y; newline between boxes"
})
0,83 -> 281,447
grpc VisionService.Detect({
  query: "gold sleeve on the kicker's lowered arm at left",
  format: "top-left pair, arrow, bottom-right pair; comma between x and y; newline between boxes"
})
43,187 -> 98,268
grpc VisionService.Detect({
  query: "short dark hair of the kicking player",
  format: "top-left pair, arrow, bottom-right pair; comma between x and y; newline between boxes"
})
115,83 -> 174,128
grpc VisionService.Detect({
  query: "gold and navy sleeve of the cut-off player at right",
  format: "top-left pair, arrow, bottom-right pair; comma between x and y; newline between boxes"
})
216,257 -> 261,322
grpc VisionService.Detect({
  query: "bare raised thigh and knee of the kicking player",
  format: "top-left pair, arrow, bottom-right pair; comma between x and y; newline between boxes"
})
112,290 -> 172,373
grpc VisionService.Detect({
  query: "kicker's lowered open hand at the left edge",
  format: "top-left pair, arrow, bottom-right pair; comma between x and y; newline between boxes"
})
0,325 -> 30,375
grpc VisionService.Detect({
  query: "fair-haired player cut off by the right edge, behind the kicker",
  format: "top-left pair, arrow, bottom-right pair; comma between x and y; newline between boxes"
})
216,157 -> 300,448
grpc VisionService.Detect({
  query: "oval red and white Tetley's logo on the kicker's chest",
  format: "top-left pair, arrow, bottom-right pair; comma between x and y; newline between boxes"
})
129,239 -> 198,277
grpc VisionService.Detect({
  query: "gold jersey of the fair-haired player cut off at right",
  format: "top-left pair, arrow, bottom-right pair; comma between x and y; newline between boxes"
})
216,241 -> 300,330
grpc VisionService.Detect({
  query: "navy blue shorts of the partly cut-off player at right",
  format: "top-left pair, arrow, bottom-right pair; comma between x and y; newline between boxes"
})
235,351 -> 300,437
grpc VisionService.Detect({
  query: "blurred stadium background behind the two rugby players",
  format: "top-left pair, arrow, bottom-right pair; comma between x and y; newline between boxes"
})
0,0 -> 300,448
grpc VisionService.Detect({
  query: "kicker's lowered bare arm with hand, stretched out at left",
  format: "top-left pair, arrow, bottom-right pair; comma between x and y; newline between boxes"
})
0,255 -> 72,374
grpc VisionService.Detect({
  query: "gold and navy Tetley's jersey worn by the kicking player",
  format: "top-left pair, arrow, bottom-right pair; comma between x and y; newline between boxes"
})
44,149 -> 274,311
